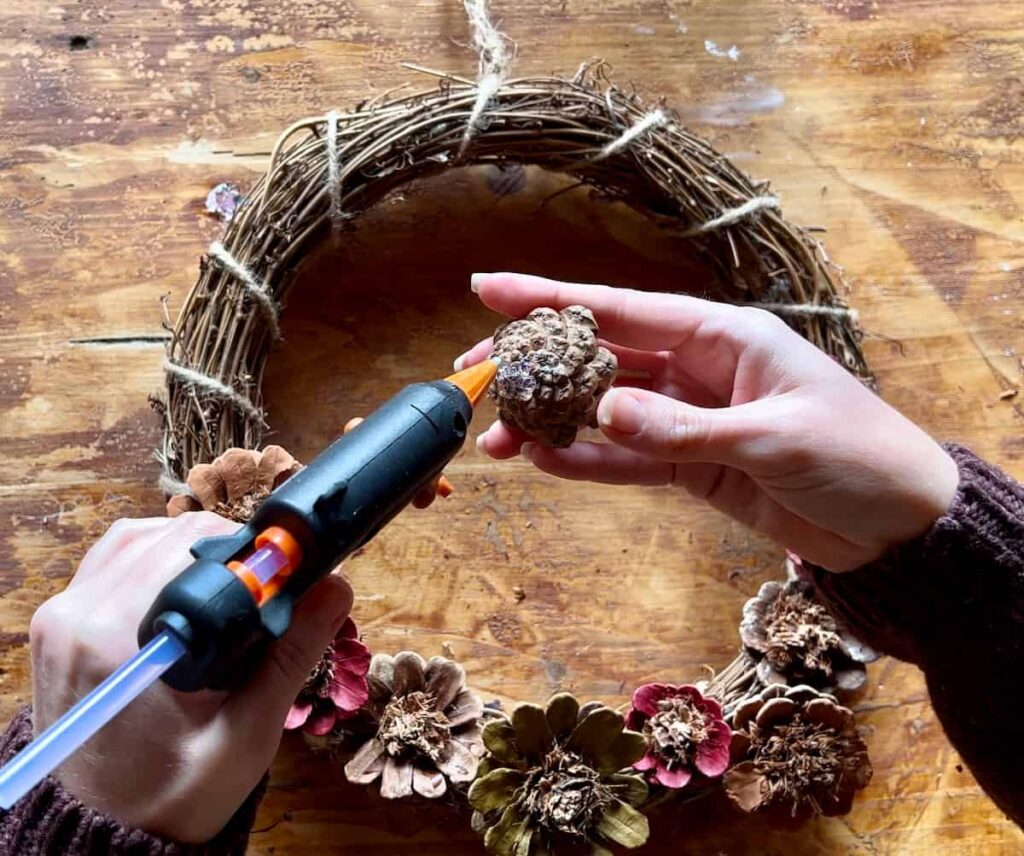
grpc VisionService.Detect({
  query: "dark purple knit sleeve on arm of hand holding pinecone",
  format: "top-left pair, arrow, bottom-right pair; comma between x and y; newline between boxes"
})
811,445 -> 1024,826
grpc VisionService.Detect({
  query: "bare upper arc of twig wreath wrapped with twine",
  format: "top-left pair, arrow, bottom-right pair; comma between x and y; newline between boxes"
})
160,63 -> 871,493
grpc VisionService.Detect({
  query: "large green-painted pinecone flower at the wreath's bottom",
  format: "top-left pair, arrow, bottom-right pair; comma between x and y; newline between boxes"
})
469,693 -> 648,856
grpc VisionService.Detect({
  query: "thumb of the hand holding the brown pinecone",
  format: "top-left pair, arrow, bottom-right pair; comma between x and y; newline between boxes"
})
597,387 -> 757,470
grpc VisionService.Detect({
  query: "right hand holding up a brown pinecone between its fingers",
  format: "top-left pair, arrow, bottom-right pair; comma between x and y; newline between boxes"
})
456,273 -> 958,570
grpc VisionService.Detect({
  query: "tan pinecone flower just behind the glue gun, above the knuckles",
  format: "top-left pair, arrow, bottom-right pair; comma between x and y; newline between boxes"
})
167,445 -> 302,523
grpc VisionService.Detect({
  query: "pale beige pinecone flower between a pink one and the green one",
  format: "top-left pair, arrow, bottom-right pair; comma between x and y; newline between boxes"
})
343,651 -> 483,800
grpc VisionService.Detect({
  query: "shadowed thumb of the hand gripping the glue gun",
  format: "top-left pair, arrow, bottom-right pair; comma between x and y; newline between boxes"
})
228,573 -> 352,731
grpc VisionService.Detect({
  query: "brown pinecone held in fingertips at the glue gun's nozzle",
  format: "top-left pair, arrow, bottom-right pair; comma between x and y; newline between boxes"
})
490,306 -> 617,447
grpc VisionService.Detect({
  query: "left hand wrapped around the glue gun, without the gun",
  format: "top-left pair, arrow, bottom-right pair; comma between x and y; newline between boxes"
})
29,512 -> 352,844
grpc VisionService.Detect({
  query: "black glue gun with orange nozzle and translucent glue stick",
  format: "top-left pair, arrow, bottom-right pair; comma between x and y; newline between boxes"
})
0,360 -> 497,809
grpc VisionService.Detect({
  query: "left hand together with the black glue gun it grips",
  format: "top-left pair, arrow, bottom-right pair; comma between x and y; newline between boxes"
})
0,361 -> 496,842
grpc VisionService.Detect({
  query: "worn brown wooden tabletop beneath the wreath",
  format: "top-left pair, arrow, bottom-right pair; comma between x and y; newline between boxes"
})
0,0 -> 1024,854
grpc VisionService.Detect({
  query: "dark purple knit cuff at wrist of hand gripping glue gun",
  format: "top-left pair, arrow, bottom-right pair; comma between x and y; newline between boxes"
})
0,708 -> 266,856
